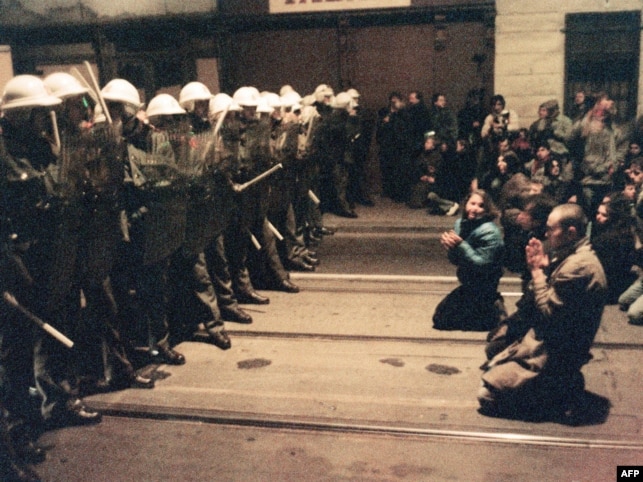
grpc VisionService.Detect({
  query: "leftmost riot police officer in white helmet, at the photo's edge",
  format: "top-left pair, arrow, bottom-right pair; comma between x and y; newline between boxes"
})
0,75 -> 101,476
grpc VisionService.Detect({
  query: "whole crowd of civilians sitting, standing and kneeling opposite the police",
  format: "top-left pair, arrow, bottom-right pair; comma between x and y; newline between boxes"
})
388,91 -> 643,423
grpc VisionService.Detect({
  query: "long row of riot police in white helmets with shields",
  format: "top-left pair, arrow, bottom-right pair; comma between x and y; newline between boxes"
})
0,69 -> 372,480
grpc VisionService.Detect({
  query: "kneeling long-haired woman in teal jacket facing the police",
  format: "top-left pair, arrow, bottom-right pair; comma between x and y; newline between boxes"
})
433,190 -> 504,331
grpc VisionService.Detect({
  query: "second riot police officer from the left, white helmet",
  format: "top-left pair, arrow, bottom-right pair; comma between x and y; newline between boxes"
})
44,72 -> 154,390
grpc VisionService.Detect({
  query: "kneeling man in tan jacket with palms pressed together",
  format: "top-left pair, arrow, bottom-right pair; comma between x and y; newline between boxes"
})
478,204 -> 607,423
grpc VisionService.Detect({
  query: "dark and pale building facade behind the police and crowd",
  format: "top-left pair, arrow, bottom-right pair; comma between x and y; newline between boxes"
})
0,0 -> 643,125
